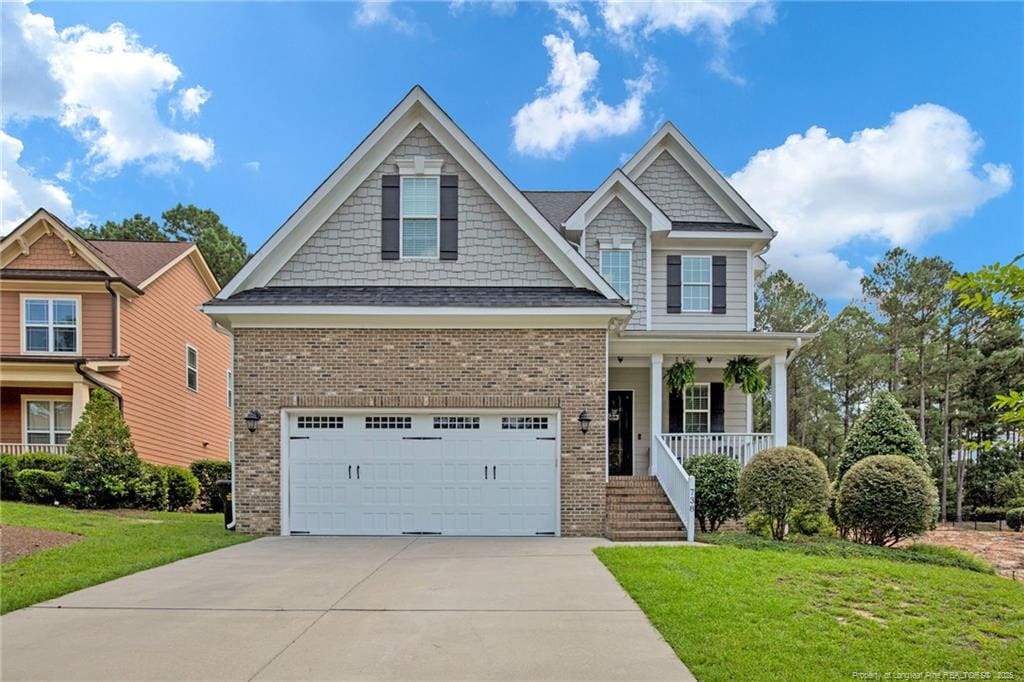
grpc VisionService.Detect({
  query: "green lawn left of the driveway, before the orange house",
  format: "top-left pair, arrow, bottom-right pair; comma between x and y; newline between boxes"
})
0,502 -> 252,613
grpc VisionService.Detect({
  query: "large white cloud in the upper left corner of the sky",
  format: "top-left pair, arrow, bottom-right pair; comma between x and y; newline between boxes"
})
0,3 -> 214,174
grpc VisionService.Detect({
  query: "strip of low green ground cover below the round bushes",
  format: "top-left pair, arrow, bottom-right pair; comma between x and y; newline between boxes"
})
697,532 -> 995,573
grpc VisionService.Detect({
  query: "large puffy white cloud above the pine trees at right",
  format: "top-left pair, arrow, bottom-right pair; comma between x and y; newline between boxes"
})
730,104 -> 1013,298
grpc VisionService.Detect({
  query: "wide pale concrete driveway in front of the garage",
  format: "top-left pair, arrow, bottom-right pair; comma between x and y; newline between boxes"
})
0,538 -> 693,680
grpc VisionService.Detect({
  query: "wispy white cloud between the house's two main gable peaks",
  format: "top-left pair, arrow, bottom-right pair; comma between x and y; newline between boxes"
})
512,35 -> 654,158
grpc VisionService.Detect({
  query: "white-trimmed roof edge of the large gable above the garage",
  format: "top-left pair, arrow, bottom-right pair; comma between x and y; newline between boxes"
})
218,85 -> 618,299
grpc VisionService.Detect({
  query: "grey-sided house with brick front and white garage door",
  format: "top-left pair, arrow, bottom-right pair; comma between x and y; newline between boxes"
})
204,87 -> 806,538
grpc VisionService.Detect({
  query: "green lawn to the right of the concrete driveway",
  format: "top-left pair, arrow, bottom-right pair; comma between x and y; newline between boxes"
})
595,543 -> 1024,681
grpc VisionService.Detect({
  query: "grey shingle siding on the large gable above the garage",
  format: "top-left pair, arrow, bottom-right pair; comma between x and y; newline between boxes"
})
269,126 -> 570,287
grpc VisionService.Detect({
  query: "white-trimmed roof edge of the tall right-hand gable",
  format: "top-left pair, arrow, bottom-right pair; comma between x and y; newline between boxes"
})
623,121 -> 775,239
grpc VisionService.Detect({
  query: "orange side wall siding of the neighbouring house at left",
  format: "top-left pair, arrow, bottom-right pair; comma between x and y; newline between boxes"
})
120,258 -> 231,466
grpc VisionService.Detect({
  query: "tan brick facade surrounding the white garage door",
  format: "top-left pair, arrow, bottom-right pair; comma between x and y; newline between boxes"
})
234,329 -> 606,536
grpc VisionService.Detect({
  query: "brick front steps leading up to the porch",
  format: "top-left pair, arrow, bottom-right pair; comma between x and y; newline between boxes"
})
607,476 -> 686,541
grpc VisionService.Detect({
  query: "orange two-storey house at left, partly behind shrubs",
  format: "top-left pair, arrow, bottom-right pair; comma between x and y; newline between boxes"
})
0,209 -> 231,466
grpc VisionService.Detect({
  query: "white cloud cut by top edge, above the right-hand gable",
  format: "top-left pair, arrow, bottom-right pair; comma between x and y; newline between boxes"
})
601,0 -> 775,84
